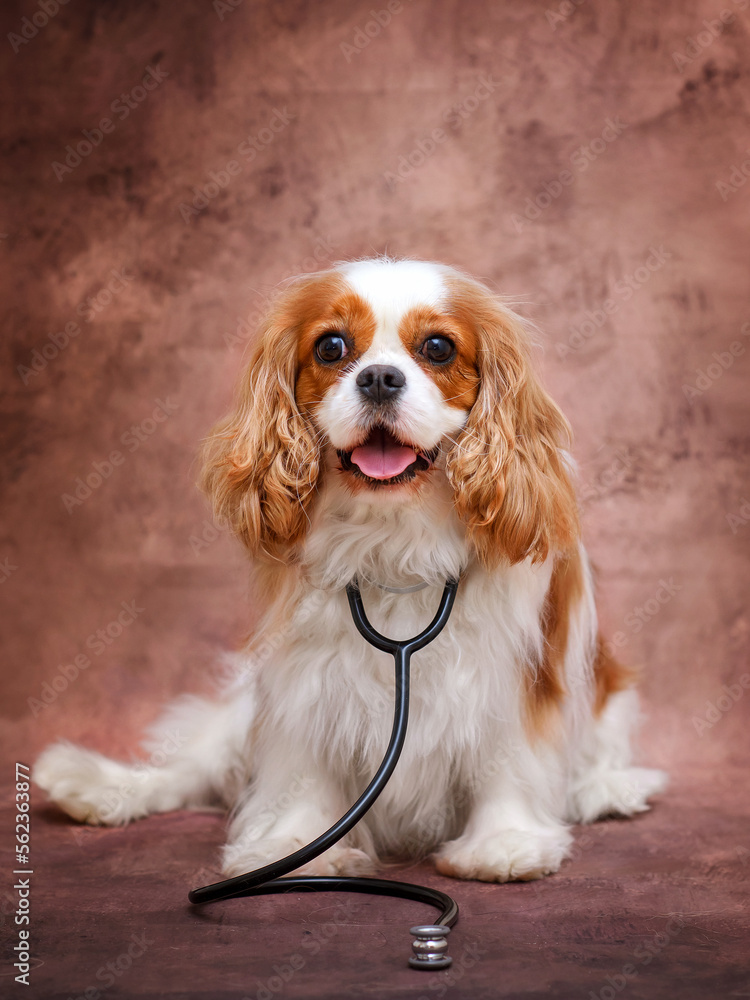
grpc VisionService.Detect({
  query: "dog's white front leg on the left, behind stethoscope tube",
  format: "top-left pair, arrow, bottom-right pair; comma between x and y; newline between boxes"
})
223,746 -> 375,875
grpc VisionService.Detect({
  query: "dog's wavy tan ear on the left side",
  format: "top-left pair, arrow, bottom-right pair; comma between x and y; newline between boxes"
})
201,279 -> 320,561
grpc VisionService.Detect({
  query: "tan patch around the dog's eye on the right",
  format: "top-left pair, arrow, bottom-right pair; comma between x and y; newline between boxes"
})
398,306 -> 479,412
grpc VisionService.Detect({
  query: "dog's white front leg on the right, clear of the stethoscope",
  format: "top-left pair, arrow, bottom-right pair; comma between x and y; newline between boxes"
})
435,747 -> 572,882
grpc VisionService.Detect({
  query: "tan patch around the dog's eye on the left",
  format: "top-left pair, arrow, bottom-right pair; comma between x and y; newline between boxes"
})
295,276 -> 376,416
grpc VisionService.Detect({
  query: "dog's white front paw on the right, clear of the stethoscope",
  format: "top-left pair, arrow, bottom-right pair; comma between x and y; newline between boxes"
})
435,829 -> 573,882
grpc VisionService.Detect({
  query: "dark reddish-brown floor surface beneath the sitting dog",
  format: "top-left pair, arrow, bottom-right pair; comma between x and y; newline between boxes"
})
2,769 -> 750,1000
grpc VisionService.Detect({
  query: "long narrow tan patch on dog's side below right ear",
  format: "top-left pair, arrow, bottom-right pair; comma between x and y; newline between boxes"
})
525,549 -> 583,737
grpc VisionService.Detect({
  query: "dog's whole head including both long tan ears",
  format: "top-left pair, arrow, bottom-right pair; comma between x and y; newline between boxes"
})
204,259 -> 577,565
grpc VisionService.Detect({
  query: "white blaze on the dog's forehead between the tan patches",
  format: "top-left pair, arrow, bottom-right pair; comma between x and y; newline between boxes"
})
343,260 -> 445,355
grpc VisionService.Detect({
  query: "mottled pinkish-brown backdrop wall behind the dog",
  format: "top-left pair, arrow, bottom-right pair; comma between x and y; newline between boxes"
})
0,0 -> 750,773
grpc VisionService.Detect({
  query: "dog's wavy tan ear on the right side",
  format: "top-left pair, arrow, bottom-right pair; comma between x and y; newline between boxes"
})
446,283 -> 578,566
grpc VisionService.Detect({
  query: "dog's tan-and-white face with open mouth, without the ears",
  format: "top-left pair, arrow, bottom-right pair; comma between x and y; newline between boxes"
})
296,261 -> 480,497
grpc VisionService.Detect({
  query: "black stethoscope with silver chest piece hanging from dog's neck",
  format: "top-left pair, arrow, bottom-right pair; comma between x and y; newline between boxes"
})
188,580 -> 458,969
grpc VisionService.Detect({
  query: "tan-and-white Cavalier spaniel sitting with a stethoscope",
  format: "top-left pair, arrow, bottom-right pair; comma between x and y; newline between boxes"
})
34,257 -> 666,882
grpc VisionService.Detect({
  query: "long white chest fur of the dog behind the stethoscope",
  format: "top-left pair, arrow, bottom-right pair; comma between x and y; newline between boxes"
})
250,484 -> 550,847
